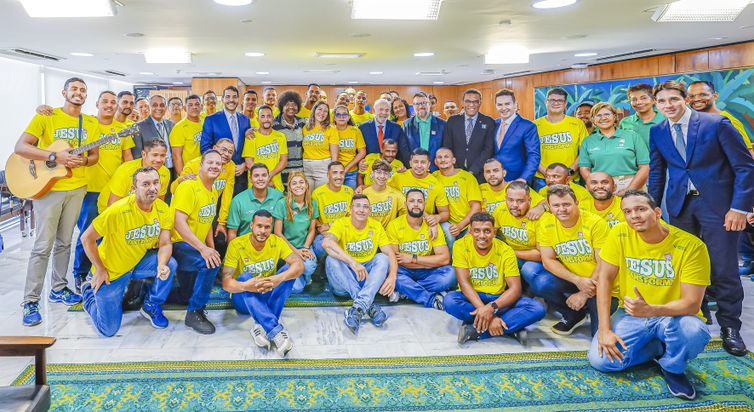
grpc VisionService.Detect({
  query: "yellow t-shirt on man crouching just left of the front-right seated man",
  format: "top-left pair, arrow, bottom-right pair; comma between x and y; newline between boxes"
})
537,210 -> 610,278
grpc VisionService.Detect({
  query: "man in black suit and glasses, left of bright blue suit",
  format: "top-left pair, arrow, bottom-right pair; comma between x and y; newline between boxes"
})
442,89 -> 496,182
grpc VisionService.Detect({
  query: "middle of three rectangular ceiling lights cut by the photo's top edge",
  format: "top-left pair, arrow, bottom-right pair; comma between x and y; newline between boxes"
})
351,0 -> 442,20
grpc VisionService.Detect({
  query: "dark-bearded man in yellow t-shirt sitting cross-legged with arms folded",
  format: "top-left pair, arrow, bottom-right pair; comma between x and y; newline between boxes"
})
384,189 -> 456,311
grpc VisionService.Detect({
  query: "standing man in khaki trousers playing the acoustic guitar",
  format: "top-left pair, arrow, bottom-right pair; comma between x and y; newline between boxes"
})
14,77 -> 99,326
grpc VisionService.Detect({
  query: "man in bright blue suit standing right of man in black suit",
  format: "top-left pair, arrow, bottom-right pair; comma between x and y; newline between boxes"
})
495,89 -> 541,184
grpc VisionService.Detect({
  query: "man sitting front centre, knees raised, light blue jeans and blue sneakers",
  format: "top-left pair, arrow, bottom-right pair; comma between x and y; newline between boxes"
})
322,195 -> 398,334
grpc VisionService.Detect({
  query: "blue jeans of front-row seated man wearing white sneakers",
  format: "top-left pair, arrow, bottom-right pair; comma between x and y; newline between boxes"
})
230,274 -> 296,339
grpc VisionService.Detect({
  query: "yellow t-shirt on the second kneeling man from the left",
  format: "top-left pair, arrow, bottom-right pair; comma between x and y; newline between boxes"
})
170,179 -> 217,243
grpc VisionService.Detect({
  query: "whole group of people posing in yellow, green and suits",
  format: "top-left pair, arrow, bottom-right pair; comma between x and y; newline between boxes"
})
16,78 -> 754,399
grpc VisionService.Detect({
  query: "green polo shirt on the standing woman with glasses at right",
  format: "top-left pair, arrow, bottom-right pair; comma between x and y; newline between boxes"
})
579,129 -> 649,176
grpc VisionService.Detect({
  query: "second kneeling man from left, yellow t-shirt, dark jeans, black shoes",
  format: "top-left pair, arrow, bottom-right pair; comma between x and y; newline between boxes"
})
170,150 -> 222,335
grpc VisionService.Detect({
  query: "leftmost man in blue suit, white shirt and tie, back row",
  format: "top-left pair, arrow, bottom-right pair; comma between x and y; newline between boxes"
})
200,86 -> 251,195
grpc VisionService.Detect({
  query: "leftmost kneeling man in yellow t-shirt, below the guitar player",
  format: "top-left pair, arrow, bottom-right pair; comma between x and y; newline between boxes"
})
81,167 -> 177,337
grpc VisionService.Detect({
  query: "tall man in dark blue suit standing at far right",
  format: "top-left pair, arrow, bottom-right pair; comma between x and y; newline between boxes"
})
649,81 -> 754,356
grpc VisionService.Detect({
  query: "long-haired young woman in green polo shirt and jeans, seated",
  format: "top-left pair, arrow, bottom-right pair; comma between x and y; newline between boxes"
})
272,171 -> 319,293
